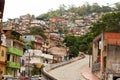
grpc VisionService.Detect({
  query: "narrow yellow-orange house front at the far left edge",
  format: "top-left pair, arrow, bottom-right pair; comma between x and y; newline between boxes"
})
0,45 -> 6,78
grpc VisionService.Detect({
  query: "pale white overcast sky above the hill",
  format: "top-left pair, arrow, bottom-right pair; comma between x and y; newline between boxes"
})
3,0 -> 120,21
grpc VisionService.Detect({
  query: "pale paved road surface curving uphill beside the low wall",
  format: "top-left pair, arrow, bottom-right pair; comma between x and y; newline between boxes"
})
49,56 -> 89,80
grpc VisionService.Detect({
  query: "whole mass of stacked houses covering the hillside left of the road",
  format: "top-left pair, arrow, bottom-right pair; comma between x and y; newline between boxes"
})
0,8 -> 106,76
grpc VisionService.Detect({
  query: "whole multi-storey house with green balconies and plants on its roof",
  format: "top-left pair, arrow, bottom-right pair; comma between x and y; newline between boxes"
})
4,30 -> 24,76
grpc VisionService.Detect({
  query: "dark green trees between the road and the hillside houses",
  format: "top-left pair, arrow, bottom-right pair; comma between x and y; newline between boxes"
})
64,12 -> 120,55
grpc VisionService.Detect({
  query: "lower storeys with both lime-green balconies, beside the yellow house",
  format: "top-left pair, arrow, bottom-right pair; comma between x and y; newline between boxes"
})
6,47 -> 23,76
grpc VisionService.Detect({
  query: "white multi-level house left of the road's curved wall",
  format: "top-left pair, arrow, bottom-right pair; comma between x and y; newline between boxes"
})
21,49 -> 53,73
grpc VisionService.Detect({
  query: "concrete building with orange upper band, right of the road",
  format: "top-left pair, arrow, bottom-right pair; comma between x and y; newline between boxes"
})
92,33 -> 120,80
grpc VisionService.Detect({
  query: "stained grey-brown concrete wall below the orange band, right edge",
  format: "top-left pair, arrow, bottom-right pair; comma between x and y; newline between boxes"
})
106,45 -> 120,73
